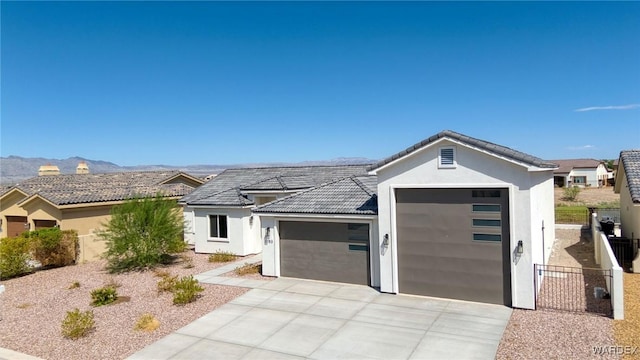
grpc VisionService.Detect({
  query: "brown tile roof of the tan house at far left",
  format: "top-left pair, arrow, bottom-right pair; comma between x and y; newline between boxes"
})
0,171 -> 200,205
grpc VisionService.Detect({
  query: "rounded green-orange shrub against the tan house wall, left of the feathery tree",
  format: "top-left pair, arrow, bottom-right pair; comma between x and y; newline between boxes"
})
25,228 -> 79,266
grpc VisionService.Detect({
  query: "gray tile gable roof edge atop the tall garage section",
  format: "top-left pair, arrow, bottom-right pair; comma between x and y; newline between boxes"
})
369,130 -> 557,170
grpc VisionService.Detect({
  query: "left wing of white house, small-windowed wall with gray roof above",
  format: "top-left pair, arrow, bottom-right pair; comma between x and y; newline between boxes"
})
180,165 -> 368,255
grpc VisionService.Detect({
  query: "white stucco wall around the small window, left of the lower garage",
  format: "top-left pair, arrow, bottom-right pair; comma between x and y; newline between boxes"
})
190,207 -> 260,256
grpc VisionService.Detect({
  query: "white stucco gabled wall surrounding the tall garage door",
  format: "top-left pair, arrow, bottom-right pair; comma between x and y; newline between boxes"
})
377,139 -> 555,309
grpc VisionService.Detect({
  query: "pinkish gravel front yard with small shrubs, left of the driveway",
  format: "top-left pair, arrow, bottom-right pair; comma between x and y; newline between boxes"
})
0,251 -> 248,360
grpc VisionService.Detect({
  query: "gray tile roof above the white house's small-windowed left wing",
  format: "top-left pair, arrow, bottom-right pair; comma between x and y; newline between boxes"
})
180,164 -> 370,206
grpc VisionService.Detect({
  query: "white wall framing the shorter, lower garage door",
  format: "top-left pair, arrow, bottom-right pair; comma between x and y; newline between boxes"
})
260,215 -> 380,287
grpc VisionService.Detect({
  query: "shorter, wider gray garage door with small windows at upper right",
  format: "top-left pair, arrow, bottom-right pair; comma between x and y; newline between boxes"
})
279,221 -> 369,285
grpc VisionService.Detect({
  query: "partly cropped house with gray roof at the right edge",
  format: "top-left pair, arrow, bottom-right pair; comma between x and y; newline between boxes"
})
614,150 -> 640,239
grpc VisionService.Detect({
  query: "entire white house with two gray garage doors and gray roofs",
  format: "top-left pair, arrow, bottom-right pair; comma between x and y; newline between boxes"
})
181,131 -> 557,309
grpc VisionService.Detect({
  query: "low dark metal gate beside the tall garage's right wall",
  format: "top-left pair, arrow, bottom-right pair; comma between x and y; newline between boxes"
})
534,264 -> 613,316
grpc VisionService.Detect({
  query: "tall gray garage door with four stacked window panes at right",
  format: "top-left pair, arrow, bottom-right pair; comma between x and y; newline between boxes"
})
396,189 -> 511,306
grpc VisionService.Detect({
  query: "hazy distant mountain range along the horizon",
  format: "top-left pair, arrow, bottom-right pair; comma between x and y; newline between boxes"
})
0,156 -> 375,185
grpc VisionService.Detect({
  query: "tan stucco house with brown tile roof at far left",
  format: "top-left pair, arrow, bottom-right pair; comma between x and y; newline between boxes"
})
0,170 -> 203,249
